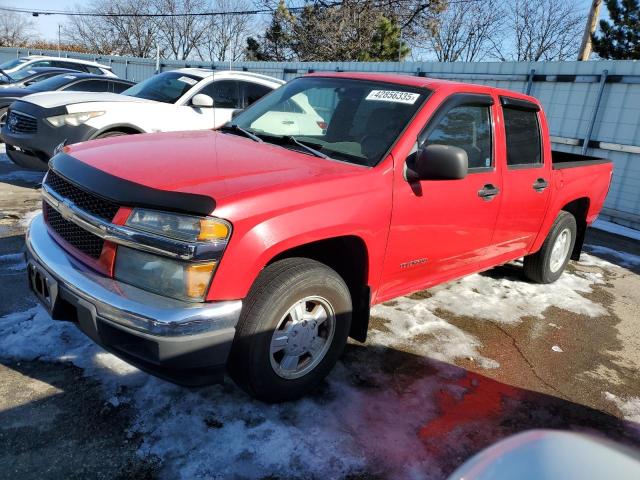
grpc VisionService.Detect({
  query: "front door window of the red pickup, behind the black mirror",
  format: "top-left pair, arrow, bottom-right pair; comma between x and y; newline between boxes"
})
425,105 -> 493,169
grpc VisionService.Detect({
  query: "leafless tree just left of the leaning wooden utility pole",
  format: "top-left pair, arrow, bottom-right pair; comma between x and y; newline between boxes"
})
491,0 -> 584,62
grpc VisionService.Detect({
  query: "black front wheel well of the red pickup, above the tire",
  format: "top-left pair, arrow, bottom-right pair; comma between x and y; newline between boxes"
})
267,235 -> 371,342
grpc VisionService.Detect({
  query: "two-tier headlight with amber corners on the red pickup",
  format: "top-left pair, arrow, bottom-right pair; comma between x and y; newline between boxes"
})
114,208 -> 231,302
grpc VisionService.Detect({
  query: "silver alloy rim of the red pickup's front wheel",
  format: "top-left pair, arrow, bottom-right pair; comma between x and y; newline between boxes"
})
269,296 -> 336,380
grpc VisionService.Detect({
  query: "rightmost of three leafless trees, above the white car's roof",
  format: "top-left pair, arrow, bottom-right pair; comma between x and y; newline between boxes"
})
196,0 -> 253,62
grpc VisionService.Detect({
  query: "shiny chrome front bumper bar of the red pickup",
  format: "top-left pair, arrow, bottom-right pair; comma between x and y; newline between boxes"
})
26,215 -> 242,336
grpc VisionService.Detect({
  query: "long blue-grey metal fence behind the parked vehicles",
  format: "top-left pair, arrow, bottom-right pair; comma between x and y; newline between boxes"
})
0,48 -> 640,229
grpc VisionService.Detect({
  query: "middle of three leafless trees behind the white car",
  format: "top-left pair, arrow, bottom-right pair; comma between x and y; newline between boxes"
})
156,0 -> 210,60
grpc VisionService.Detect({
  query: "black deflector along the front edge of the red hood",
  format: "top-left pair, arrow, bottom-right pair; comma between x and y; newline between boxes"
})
49,153 -> 216,215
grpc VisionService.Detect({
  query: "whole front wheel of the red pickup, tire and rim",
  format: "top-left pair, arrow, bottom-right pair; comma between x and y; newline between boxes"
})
228,258 -> 352,403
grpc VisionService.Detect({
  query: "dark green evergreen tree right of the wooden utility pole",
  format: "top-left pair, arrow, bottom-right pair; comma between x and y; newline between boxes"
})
592,0 -> 640,60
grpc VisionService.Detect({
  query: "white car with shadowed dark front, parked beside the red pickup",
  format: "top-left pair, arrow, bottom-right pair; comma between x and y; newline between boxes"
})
1,68 -> 284,170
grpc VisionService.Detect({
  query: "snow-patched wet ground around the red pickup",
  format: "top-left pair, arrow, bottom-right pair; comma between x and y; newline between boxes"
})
0,147 -> 640,479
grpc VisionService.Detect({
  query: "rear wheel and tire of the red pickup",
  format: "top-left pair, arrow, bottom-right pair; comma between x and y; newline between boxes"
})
524,211 -> 578,283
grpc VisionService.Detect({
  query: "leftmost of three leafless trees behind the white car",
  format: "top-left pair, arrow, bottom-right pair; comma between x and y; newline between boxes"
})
64,0 -> 158,57
